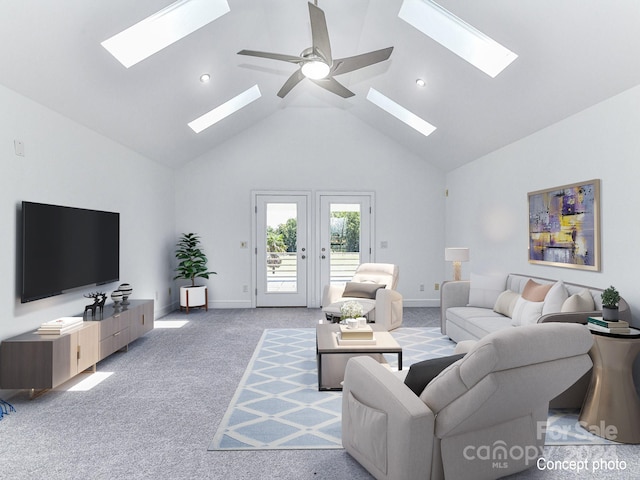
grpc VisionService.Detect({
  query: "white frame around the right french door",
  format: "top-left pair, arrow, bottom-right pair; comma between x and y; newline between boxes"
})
316,190 -> 376,308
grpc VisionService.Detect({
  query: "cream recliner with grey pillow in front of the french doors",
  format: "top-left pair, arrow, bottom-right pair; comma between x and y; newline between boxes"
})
322,263 -> 402,331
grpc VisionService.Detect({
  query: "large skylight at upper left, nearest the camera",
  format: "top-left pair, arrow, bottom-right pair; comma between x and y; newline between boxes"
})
102,0 -> 234,68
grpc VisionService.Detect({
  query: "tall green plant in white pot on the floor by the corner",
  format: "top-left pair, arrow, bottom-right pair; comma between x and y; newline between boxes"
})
173,233 -> 217,313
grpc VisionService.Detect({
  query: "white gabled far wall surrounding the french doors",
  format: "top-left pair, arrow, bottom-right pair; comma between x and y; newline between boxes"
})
176,108 -> 444,307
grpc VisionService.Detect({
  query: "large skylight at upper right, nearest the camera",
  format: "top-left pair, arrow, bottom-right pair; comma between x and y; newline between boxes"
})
398,0 -> 518,78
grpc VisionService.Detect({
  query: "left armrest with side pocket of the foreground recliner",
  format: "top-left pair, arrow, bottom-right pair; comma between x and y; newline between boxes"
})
342,356 -> 435,480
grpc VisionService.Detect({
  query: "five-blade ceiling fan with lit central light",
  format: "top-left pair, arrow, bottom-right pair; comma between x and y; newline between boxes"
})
238,2 -> 393,98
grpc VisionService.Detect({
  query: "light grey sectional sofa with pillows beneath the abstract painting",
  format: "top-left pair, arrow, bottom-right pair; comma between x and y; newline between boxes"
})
440,273 -> 631,342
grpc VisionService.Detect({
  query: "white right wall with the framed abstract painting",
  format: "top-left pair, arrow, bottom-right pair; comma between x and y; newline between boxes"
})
446,86 -> 640,326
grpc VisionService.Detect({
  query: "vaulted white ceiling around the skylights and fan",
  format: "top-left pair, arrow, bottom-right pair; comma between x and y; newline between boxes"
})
0,0 -> 640,171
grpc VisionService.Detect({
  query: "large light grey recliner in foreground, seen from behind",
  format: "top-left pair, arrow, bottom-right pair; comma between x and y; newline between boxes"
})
342,323 -> 593,480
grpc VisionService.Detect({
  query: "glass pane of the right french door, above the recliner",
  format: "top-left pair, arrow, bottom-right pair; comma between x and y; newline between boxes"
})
329,203 -> 360,285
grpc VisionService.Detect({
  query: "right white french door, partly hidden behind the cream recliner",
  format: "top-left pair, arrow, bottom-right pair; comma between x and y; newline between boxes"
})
318,194 -> 373,289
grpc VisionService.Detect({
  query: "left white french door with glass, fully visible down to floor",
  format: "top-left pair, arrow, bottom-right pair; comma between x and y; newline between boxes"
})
255,194 -> 309,307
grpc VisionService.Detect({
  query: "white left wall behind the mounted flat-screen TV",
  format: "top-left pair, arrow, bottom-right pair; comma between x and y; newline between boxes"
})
0,83 -> 174,340
